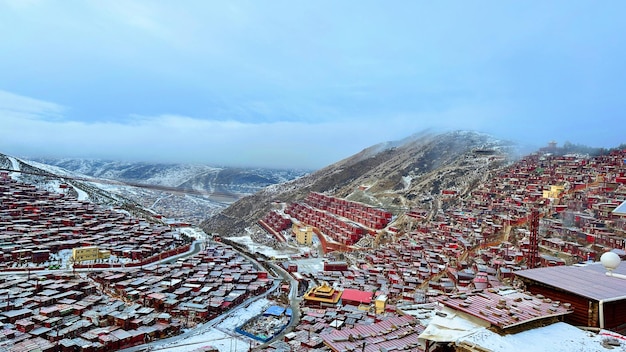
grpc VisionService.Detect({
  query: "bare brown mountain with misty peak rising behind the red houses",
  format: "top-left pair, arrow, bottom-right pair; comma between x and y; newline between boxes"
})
201,131 -> 516,236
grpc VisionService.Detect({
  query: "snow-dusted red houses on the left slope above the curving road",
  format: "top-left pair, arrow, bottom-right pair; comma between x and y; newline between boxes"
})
0,173 -> 189,270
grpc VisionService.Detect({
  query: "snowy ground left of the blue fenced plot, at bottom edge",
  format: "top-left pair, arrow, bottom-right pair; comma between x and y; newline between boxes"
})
153,298 -> 272,352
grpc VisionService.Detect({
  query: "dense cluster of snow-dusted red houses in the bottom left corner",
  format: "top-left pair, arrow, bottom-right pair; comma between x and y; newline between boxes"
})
0,273 -> 182,352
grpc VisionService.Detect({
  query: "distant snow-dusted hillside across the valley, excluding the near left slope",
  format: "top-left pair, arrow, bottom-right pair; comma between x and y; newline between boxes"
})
20,158 -> 306,224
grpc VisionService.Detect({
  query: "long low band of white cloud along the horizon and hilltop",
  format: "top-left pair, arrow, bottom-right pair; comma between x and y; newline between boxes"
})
0,91 -> 616,168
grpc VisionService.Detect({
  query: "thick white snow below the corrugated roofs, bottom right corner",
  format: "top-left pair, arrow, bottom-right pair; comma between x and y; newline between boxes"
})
457,323 -> 626,352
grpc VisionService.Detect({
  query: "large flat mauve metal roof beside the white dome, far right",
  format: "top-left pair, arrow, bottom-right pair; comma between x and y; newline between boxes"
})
515,263 -> 626,301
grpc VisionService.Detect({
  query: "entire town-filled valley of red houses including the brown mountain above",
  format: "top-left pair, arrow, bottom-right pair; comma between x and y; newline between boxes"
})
0,132 -> 626,352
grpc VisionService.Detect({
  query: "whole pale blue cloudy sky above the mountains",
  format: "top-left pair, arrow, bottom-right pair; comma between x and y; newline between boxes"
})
0,0 -> 626,169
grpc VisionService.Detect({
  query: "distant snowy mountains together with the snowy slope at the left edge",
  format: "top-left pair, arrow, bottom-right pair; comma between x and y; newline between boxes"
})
0,154 -> 307,224
